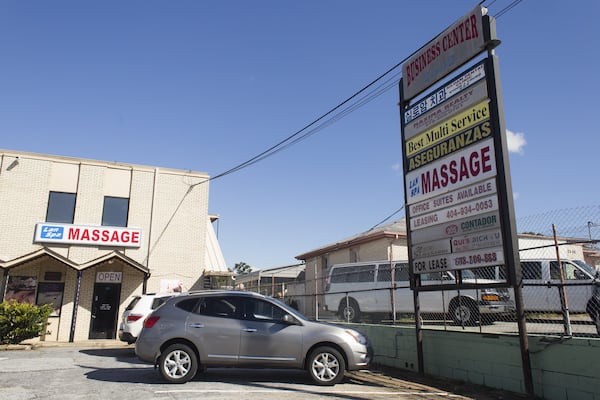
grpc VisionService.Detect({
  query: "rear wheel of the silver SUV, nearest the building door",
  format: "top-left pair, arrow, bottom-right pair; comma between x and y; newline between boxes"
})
158,343 -> 198,383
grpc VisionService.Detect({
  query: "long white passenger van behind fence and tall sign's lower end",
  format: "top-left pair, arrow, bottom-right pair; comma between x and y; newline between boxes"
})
325,261 -> 514,325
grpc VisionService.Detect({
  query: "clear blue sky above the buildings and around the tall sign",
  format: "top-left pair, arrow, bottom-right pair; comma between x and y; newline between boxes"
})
0,0 -> 600,269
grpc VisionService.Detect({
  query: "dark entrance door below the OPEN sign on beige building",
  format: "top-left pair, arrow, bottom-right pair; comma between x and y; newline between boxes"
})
89,283 -> 121,339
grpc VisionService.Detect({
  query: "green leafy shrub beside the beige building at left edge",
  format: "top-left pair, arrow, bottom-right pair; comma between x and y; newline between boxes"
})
0,300 -> 52,344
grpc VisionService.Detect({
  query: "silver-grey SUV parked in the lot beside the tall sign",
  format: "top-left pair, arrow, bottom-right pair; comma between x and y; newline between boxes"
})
135,291 -> 372,385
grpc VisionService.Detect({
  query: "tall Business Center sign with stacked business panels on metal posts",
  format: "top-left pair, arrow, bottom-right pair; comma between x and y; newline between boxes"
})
399,6 -> 533,395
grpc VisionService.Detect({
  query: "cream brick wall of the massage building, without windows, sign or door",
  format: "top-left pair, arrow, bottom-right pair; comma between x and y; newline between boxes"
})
0,150 -> 210,341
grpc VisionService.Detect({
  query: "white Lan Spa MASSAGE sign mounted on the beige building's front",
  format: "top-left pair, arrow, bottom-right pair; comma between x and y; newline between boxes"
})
34,223 -> 142,247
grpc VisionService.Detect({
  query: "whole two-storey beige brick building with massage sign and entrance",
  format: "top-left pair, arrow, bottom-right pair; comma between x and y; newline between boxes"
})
0,150 -> 231,341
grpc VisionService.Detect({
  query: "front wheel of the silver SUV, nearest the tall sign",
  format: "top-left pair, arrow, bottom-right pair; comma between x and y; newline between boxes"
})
307,346 -> 346,386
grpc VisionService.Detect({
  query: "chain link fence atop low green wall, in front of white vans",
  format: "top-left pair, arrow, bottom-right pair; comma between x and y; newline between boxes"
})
239,207 -> 600,337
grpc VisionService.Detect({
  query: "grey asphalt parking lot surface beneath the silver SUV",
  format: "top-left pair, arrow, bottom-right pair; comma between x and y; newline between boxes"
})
0,341 -> 523,400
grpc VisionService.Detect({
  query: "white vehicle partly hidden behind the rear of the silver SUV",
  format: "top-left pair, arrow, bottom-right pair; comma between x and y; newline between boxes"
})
119,293 -> 173,344
